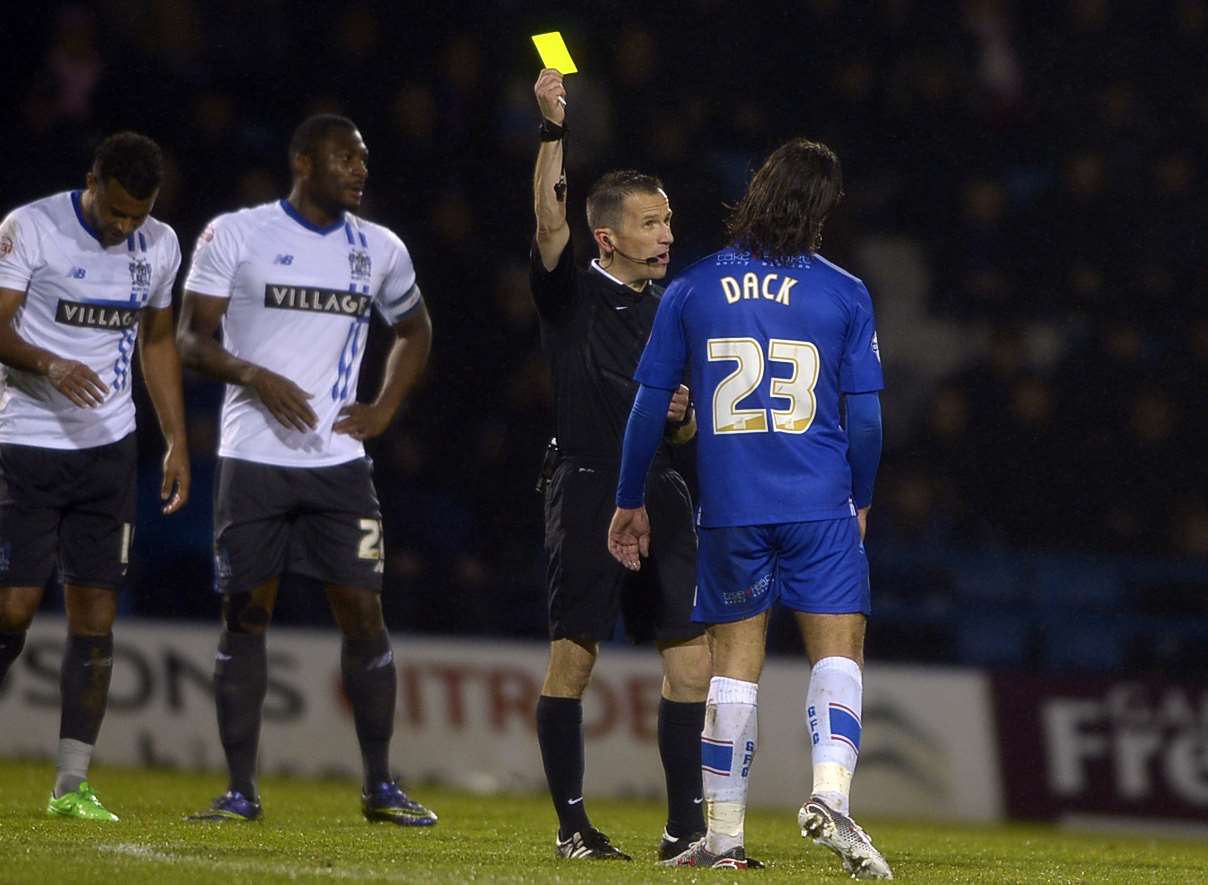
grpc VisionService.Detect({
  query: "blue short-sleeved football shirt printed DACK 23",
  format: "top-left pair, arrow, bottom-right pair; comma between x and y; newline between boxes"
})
635,249 -> 884,528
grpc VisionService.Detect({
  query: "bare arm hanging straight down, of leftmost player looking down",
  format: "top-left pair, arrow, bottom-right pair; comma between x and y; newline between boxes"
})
139,307 -> 190,514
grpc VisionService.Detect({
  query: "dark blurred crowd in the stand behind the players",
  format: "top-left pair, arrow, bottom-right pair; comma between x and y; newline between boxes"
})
0,0 -> 1208,636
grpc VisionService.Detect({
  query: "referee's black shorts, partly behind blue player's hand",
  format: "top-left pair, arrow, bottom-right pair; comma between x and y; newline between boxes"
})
545,459 -> 704,642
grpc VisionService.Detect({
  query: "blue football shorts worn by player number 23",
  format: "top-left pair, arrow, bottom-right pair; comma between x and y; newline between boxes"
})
692,517 -> 872,624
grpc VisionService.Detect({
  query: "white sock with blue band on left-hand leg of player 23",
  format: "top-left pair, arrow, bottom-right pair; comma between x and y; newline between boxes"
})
701,676 -> 759,854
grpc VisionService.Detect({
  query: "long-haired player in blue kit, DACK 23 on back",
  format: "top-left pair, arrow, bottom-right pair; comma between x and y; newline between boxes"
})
608,139 -> 893,879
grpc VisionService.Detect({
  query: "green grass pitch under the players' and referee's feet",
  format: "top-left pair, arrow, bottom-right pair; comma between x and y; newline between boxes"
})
0,762 -> 1208,885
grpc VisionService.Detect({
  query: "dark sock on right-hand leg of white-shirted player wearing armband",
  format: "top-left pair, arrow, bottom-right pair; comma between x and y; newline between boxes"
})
339,630 -> 399,788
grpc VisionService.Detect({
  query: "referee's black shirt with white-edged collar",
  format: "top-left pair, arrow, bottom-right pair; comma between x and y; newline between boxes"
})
529,233 -> 670,466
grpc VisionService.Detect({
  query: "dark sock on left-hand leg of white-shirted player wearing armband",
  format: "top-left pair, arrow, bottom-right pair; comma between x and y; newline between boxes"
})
214,630 -> 268,800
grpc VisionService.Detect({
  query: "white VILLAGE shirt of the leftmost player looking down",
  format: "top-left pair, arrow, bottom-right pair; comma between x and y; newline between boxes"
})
0,191 -> 180,449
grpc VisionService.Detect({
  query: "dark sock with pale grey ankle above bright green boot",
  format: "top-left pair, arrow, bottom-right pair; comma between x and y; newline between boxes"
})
54,633 -> 114,796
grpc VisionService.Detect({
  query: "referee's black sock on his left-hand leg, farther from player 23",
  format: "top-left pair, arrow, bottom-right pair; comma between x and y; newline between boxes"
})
536,694 -> 591,839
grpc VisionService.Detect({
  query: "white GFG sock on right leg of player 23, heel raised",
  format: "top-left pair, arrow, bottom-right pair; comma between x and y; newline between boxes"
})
806,658 -> 864,814
